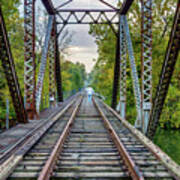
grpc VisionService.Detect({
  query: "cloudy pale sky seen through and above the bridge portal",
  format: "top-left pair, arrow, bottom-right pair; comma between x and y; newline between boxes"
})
20,0 -> 118,73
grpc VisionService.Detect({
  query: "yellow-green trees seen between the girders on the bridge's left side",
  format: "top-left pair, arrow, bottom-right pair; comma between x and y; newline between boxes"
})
0,0 -> 86,127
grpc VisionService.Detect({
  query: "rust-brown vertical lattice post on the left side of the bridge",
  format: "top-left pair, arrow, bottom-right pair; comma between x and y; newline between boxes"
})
24,0 -> 36,119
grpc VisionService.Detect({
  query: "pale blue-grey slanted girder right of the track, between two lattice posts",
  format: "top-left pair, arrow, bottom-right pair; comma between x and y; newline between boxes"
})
122,15 -> 142,129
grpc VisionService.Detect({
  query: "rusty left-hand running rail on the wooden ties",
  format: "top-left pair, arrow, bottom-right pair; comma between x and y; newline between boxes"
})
38,97 -> 83,180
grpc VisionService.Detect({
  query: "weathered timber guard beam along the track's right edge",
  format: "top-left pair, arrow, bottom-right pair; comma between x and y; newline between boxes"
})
99,100 -> 180,180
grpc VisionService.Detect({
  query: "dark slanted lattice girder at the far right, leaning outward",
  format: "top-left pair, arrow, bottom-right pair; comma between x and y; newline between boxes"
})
147,0 -> 180,139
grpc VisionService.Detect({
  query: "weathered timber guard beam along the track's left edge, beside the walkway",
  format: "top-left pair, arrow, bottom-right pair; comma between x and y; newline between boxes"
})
0,95 -> 79,179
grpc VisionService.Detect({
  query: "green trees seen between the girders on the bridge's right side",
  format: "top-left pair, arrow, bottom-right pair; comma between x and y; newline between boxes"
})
89,0 -> 180,128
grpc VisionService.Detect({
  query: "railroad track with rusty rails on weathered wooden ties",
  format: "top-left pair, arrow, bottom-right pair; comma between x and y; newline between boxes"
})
0,93 -> 179,180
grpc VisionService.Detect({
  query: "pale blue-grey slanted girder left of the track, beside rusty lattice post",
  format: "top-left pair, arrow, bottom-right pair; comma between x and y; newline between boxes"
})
36,15 -> 54,113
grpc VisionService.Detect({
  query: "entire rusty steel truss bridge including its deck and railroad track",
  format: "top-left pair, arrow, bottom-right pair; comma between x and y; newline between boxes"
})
0,0 -> 180,180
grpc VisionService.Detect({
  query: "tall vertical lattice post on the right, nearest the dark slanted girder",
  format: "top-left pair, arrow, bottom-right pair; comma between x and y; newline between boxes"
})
141,0 -> 152,133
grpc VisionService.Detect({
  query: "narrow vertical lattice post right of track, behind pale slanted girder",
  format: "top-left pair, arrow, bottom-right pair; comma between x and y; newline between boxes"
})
119,17 -> 127,118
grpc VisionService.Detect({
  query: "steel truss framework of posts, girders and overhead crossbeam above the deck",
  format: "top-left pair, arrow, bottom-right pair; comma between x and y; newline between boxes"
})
1,0 -> 180,138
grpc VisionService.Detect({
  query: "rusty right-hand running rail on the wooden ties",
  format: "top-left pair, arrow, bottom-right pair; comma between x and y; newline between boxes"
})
93,98 -> 144,180
